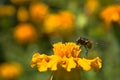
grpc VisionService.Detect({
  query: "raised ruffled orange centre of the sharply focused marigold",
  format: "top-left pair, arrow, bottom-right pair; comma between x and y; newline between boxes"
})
53,42 -> 81,58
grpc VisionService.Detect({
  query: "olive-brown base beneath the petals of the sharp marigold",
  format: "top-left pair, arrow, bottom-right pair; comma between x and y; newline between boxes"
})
50,67 -> 81,80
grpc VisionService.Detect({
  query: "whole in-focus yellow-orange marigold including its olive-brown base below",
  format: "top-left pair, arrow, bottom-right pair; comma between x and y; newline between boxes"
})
31,42 -> 102,80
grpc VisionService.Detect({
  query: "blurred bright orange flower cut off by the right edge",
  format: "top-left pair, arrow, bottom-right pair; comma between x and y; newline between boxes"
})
100,5 -> 120,29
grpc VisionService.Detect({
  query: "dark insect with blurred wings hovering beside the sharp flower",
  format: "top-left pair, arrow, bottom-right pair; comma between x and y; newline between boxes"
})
76,37 -> 109,57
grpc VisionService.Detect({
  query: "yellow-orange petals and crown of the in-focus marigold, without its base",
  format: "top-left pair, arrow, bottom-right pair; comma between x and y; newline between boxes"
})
31,42 -> 102,72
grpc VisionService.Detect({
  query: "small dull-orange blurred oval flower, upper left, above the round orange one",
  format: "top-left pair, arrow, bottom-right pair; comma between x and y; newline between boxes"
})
17,6 -> 29,22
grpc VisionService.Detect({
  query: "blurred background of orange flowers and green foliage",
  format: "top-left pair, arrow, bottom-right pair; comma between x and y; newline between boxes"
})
0,0 -> 120,80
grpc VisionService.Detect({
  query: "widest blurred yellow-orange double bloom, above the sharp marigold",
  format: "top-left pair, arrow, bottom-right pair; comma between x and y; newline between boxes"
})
44,11 -> 74,36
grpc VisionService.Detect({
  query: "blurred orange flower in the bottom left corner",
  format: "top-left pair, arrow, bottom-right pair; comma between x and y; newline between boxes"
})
0,62 -> 22,80
